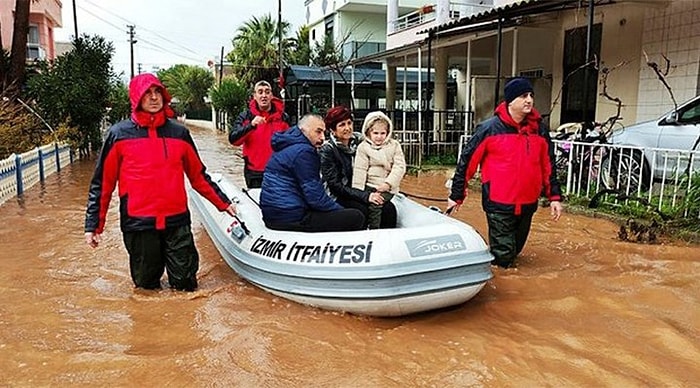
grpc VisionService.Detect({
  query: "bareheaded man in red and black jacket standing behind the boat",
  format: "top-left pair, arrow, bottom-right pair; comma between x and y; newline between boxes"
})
228,81 -> 289,189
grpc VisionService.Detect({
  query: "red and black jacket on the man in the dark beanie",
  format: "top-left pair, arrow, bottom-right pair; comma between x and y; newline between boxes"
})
450,103 -> 561,214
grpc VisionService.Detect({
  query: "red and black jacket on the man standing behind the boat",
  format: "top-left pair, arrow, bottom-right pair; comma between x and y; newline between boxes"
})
228,97 -> 289,172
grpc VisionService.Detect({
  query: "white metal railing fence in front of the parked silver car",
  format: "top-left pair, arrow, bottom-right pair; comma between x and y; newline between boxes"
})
554,140 -> 700,218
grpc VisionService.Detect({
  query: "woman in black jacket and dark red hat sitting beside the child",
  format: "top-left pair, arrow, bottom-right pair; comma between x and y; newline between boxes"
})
319,105 -> 396,228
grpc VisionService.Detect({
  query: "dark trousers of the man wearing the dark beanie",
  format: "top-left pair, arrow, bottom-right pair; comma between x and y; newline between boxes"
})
486,213 -> 533,268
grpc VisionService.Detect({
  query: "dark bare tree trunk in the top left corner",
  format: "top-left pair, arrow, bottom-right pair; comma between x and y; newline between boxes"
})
5,0 -> 31,90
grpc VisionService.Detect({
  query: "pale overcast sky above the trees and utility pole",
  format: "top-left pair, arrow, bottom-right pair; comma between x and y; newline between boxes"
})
55,0 -> 306,78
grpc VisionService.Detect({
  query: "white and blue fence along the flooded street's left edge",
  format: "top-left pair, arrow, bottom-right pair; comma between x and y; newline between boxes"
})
0,143 -> 73,204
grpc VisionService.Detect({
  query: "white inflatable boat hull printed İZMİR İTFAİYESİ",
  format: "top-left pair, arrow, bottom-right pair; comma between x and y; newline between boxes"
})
190,174 -> 493,316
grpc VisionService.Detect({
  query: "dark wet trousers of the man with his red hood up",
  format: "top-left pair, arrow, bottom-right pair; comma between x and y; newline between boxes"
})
123,225 -> 199,291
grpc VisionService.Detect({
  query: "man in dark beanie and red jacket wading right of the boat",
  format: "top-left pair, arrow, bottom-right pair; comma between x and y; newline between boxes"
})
447,78 -> 562,268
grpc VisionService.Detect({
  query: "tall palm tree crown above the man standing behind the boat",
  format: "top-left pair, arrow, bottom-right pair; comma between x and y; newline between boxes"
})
226,14 -> 293,84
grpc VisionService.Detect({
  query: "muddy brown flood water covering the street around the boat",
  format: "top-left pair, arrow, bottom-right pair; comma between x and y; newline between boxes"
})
0,126 -> 700,387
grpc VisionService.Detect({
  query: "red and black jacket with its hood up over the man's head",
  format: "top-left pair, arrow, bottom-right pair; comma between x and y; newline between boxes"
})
85,76 -> 231,233
